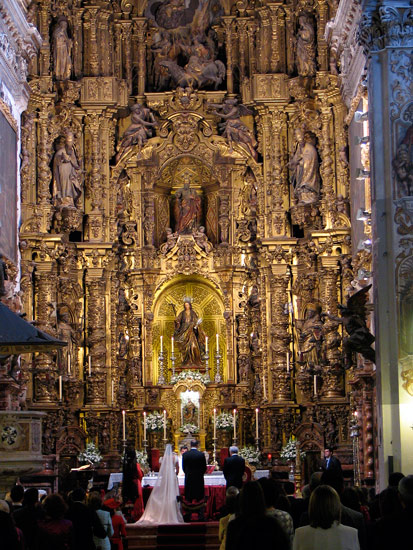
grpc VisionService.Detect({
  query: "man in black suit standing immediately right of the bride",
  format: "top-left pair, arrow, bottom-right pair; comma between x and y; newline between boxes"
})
182,441 -> 206,521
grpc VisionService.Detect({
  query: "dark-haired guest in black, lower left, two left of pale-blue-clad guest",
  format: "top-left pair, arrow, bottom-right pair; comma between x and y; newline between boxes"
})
36,494 -> 75,550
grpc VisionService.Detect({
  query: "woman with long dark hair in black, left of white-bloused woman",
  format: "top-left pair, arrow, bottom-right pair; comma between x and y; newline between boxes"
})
225,481 -> 289,550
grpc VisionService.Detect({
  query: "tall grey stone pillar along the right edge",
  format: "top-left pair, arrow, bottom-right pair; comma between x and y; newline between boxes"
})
359,0 -> 413,488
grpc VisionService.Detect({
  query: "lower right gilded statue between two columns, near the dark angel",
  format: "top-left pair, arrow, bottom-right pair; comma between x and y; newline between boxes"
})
296,303 -> 323,365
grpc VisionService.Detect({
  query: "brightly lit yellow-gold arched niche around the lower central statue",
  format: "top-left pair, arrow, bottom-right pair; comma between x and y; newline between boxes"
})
151,275 -> 228,383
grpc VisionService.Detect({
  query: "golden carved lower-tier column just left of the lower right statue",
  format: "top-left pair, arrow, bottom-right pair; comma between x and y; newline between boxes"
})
270,270 -> 291,402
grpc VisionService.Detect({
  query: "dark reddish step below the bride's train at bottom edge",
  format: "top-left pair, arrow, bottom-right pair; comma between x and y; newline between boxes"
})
126,522 -> 220,550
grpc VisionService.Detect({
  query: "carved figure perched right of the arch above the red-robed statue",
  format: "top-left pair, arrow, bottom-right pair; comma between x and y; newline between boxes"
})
208,98 -> 258,160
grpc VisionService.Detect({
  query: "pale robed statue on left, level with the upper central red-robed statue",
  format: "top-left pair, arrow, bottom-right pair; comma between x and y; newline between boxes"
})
53,132 -> 82,207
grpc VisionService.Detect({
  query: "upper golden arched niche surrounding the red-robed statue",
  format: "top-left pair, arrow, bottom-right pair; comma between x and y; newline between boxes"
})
154,155 -> 219,246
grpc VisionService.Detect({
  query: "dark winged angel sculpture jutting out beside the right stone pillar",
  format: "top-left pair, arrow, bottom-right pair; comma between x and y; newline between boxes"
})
326,285 -> 376,364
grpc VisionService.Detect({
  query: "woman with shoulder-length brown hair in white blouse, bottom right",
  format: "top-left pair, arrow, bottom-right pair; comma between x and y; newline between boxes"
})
293,485 -> 360,550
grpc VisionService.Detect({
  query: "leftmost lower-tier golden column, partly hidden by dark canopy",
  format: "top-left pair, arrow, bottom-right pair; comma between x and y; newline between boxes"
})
33,261 -> 59,403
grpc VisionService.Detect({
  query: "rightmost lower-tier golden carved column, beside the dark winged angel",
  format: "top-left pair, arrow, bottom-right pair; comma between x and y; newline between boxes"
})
320,256 -> 344,398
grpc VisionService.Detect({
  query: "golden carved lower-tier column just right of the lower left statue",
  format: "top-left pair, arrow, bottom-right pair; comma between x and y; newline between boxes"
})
86,274 -> 106,405
